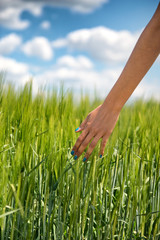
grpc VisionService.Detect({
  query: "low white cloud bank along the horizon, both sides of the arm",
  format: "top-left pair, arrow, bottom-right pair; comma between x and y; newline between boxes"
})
0,55 -> 160,101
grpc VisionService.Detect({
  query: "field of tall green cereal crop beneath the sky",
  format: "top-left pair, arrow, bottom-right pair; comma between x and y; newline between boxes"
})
0,81 -> 160,240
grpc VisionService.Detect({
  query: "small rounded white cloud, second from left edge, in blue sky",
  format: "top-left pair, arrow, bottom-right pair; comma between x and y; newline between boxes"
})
22,37 -> 53,60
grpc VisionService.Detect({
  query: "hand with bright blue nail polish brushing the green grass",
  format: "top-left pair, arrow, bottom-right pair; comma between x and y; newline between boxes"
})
71,104 -> 120,162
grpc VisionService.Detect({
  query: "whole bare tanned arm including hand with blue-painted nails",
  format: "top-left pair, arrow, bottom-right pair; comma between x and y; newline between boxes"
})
71,3 -> 160,162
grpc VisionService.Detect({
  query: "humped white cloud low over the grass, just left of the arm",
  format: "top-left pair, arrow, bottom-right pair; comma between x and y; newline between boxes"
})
34,55 -> 121,97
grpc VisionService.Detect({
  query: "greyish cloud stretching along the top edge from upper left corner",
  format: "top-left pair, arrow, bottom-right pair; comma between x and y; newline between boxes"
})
0,0 -> 108,29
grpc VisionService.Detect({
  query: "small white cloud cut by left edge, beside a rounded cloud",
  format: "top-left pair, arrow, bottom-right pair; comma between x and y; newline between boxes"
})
0,33 -> 22,55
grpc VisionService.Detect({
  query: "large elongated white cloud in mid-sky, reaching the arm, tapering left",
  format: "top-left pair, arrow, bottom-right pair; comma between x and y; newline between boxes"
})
52,27 -> 139,63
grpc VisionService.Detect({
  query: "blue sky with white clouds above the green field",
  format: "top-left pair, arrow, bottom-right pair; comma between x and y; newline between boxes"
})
0,0 -> 160,99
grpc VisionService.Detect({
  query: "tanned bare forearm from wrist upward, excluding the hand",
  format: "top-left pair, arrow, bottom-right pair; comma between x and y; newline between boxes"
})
104,4 -> 160,110
